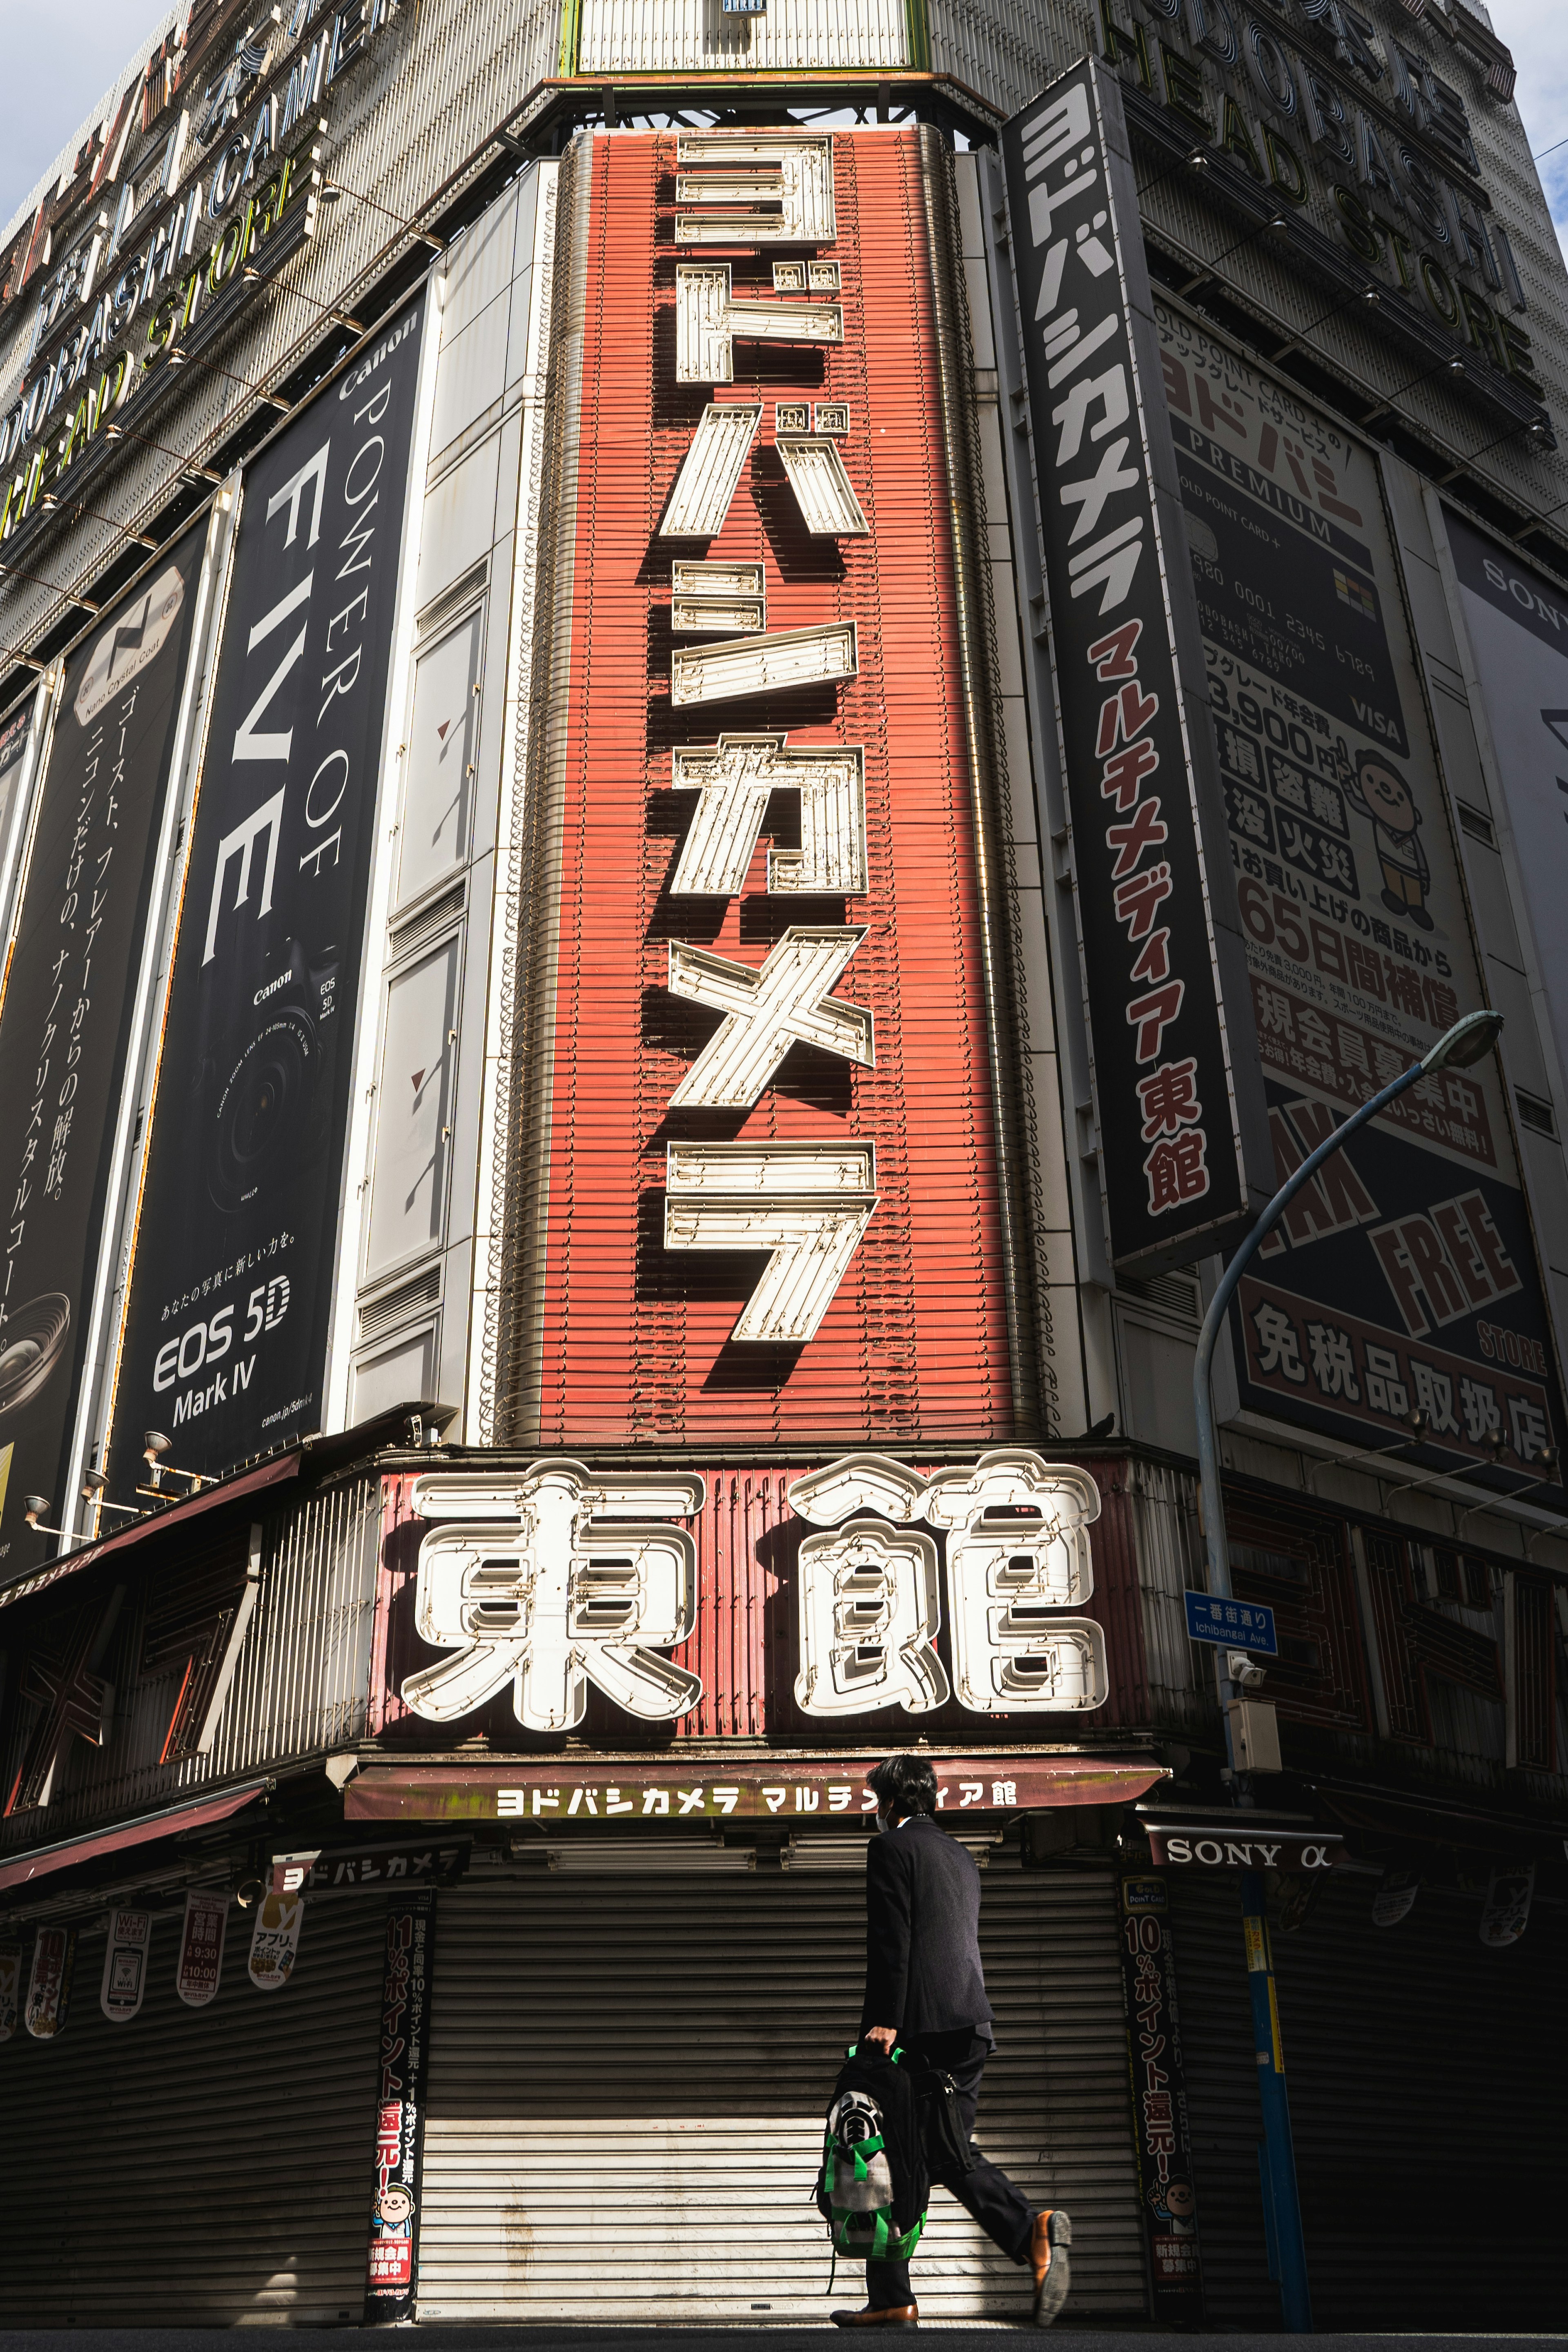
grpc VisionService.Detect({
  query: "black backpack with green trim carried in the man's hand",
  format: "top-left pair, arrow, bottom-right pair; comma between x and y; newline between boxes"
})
816,2044 -> 931,2263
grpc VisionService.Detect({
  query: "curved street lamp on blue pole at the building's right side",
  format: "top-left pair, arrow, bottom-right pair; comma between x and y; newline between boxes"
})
1192,1011 -> 1502,2336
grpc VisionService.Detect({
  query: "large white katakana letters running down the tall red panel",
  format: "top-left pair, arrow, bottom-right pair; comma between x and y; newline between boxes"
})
658,132 -> 879,1354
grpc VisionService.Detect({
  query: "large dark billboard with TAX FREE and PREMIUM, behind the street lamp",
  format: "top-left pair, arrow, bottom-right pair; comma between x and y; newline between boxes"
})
1159,308 -> 1563,1484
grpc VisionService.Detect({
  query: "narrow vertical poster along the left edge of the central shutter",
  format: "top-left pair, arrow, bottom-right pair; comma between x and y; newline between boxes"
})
364,1891 -> 435,2326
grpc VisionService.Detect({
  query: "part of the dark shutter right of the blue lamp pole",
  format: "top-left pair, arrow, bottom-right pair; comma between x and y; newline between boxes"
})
1274,1872 -> 1568,2331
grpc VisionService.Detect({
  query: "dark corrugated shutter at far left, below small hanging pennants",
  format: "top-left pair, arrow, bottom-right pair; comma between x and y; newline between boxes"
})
0,1900 -> 385,2326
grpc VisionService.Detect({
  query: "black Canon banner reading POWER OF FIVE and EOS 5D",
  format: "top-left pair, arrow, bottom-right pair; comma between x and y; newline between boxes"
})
111,303 -> 421,1494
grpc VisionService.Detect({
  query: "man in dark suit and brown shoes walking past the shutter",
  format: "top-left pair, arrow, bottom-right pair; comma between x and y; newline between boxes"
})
832,1757 -> 1072,2328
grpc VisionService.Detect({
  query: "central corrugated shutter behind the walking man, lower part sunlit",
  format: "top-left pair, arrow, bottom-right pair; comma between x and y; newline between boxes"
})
419,1865 -> 1145,2324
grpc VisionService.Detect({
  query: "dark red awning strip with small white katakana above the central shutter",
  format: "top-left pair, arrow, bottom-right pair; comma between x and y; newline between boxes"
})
343,1752 -> 1168,1823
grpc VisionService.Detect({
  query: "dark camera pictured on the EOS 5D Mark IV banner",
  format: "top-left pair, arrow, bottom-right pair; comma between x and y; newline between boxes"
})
195,938 -> 339,1216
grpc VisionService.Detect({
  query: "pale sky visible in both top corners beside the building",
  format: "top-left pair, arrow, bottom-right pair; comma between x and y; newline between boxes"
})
0,0 -> 1568,252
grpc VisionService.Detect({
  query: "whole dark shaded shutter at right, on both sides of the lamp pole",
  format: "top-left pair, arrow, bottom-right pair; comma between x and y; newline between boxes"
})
1171,1872 -> 1568,2331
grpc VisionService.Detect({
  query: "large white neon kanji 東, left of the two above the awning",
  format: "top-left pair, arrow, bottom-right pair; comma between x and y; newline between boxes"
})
402,1461 -> 705,1731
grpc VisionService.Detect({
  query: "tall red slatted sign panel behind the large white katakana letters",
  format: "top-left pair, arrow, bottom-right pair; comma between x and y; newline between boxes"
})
524,129 -> 1013,1446
